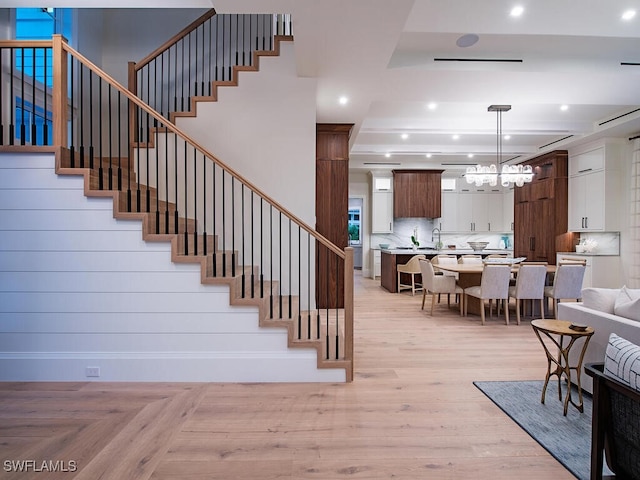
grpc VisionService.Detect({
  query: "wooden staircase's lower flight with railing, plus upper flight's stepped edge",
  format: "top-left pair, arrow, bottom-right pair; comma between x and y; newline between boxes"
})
0,11 -> 353,381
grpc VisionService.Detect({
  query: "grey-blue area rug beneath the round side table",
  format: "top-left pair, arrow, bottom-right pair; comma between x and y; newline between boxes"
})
473,380 -> 610,480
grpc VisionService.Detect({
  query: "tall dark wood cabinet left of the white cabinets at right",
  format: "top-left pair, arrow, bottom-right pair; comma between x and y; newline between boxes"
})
513,150 -> 574,264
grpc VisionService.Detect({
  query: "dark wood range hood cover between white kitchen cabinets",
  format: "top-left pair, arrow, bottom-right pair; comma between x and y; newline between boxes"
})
393,170 -> 443,218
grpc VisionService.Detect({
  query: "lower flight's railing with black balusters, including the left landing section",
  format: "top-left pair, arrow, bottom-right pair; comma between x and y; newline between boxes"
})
0,35 -> 353,381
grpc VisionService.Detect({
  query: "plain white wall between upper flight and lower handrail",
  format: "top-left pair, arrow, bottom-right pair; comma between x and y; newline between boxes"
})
176,42 -> 316,227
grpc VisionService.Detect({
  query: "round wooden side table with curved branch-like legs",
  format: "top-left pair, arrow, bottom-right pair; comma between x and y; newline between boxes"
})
531,320 -> 594,416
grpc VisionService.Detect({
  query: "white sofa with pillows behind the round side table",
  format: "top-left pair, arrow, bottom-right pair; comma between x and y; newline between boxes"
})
557,287 -> 640,393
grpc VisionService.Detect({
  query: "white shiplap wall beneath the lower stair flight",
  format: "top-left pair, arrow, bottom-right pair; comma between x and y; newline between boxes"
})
0,154 -> 344,382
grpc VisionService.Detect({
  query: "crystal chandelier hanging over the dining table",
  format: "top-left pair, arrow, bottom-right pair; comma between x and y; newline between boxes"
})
465,105 -> 533,187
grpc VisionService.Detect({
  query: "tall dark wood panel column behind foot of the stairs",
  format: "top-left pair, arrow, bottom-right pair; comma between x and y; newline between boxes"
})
316,124 -> 353,308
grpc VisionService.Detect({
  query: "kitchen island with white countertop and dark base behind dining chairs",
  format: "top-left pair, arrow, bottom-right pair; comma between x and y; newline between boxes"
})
380,248 -> 513,293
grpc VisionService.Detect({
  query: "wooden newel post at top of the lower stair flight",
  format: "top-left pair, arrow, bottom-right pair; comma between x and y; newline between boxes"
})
52,34 -> 68,147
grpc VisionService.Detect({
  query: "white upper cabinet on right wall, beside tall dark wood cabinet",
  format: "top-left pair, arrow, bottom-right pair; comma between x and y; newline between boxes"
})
569,142 -> 621,232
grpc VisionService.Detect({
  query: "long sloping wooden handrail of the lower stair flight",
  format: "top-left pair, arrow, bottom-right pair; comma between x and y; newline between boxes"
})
57,38 -> 345,259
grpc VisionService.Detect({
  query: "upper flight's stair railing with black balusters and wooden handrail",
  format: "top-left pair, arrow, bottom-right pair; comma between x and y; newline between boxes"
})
128,9 -> 291,126
